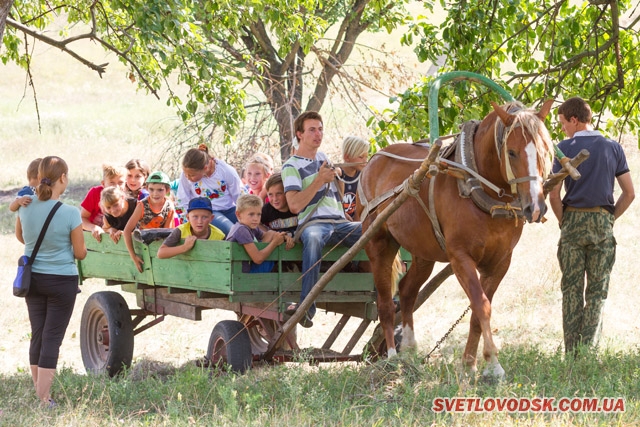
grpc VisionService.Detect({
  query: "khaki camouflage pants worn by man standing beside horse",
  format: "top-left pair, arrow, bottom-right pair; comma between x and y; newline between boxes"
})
558,211 -> 616,354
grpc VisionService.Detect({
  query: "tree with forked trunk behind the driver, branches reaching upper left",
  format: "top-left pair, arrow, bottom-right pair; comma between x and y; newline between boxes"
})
0,0 -> 416,159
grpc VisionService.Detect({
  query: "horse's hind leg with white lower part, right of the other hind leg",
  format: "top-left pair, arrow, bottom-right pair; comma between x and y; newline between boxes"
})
399,256 -> 435,351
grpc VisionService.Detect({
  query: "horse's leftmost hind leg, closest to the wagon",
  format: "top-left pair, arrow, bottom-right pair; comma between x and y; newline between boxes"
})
365,227 -> 400,357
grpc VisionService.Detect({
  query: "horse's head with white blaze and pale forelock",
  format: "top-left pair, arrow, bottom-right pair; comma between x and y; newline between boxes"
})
492,99 -> 553,222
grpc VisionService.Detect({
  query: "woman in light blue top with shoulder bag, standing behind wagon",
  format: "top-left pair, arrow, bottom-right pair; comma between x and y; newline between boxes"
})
16,156 -> 87,407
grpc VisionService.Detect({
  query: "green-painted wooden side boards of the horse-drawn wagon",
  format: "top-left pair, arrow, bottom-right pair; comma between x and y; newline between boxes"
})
78,232 -> 410,320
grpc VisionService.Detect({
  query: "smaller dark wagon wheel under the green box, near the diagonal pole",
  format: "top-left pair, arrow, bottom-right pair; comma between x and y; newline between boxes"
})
207,320 -> 253,373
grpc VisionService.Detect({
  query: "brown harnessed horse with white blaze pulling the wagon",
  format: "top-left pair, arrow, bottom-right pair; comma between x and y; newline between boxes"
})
357,100 -> 553,377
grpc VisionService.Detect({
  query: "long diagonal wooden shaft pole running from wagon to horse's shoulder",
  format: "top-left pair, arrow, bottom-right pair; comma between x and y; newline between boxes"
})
264,141 -> 442,360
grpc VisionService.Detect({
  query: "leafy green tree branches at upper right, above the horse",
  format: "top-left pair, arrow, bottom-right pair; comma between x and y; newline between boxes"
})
370,0 -> 640,145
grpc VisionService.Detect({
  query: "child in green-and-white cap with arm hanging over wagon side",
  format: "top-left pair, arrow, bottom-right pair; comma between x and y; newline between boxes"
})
123,171 -> 175,273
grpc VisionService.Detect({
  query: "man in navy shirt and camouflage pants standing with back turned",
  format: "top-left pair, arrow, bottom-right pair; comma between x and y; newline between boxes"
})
549,97 -> 635,355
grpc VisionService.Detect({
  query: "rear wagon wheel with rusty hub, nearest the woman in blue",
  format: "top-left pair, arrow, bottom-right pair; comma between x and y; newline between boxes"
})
80,291 -> 133,377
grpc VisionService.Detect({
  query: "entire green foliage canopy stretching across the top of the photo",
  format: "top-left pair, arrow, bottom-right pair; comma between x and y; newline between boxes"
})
0,0 -> 640,154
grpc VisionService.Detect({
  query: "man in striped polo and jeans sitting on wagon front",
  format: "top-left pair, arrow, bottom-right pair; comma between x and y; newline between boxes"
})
282,111 -> 362,328
